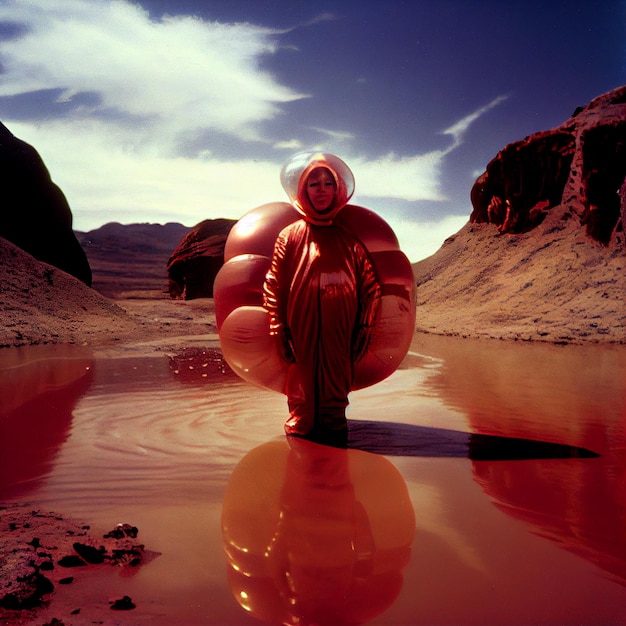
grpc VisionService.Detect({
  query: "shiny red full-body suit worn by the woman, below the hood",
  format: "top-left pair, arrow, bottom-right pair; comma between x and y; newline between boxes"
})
263,219 -> 381,435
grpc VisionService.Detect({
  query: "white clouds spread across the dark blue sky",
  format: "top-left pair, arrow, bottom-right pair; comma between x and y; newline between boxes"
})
0,0 -> 494,261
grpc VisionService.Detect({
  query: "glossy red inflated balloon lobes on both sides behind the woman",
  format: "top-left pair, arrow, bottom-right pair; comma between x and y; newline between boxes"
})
213,202 -> 415,391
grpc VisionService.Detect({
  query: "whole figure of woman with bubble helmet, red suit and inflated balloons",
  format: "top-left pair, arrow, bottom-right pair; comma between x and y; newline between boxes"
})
214,152 -> 415,398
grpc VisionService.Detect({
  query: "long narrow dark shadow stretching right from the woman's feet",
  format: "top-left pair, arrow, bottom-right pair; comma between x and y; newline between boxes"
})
348,420 -> 599,461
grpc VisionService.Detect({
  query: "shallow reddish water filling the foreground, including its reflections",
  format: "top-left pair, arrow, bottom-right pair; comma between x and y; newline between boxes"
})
0,336 -> 626,625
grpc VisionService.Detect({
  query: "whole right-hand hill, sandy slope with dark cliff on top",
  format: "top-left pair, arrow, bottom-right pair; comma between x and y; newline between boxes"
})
414,87 -> 626,343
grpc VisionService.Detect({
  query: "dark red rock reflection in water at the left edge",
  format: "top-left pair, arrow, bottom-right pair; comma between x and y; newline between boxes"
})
0,346 -> 93,500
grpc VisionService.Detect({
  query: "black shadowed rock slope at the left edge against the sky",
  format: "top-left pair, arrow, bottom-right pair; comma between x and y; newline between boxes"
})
0,123 -> 91,285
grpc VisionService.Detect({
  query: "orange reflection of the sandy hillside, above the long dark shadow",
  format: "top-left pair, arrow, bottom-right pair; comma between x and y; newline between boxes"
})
416,337 -> 626,454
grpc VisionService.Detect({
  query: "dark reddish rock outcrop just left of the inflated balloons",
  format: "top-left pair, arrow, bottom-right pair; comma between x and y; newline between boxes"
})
167,219 -> 236,300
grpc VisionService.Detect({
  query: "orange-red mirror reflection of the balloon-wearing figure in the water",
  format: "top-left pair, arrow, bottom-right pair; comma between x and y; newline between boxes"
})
222,438 -> 415,625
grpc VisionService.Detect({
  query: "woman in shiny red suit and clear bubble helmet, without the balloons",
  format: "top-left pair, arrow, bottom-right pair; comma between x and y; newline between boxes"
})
264,153 -> 380,445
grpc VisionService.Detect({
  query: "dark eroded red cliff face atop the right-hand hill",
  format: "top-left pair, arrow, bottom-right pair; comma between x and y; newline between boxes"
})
470,86 -> 626,247
